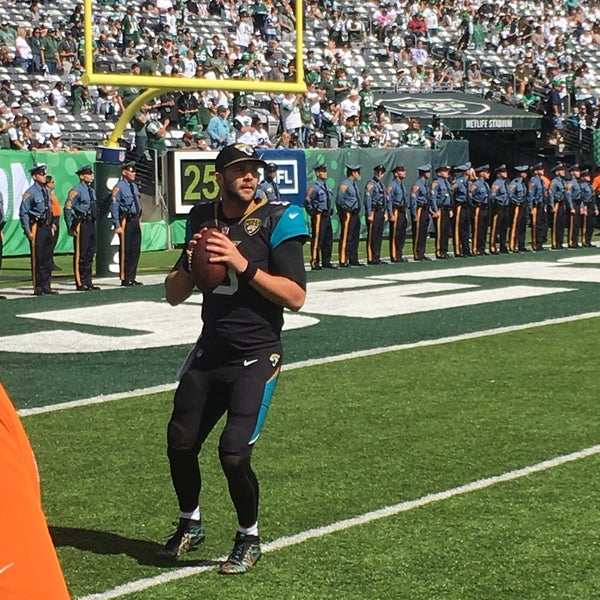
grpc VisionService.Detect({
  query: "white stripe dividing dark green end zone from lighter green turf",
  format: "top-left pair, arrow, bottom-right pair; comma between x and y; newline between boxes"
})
17,312 -> 600,417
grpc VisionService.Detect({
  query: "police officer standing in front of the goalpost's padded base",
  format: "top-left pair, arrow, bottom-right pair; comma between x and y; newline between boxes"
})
110,162 -> 142,286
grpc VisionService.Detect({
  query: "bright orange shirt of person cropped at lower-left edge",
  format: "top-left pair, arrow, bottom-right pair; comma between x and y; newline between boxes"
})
0,383 -> 69,600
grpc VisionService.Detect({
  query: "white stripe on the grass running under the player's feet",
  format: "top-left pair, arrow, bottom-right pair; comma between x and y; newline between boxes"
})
78,445 -> 600,600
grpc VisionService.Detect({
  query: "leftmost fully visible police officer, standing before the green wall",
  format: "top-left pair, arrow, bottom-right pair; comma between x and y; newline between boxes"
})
19,164 -> 58,296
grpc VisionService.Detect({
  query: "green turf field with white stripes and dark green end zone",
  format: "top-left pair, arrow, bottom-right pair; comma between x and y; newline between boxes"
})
0,246 -> 600,600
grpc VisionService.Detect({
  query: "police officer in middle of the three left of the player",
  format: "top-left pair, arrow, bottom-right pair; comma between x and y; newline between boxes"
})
63,165 -> 100,292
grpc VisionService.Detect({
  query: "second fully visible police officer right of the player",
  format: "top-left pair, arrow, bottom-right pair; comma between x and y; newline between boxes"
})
335,164 -> 362,267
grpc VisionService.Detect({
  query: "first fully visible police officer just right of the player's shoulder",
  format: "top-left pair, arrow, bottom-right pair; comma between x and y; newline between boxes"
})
306,163 -> 335,271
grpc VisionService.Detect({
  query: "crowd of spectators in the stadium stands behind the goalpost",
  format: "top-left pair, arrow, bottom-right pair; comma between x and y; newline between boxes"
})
0,0 -> 600,158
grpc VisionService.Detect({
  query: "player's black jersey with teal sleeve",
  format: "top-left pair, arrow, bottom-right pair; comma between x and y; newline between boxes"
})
175,199 -> 309,355
